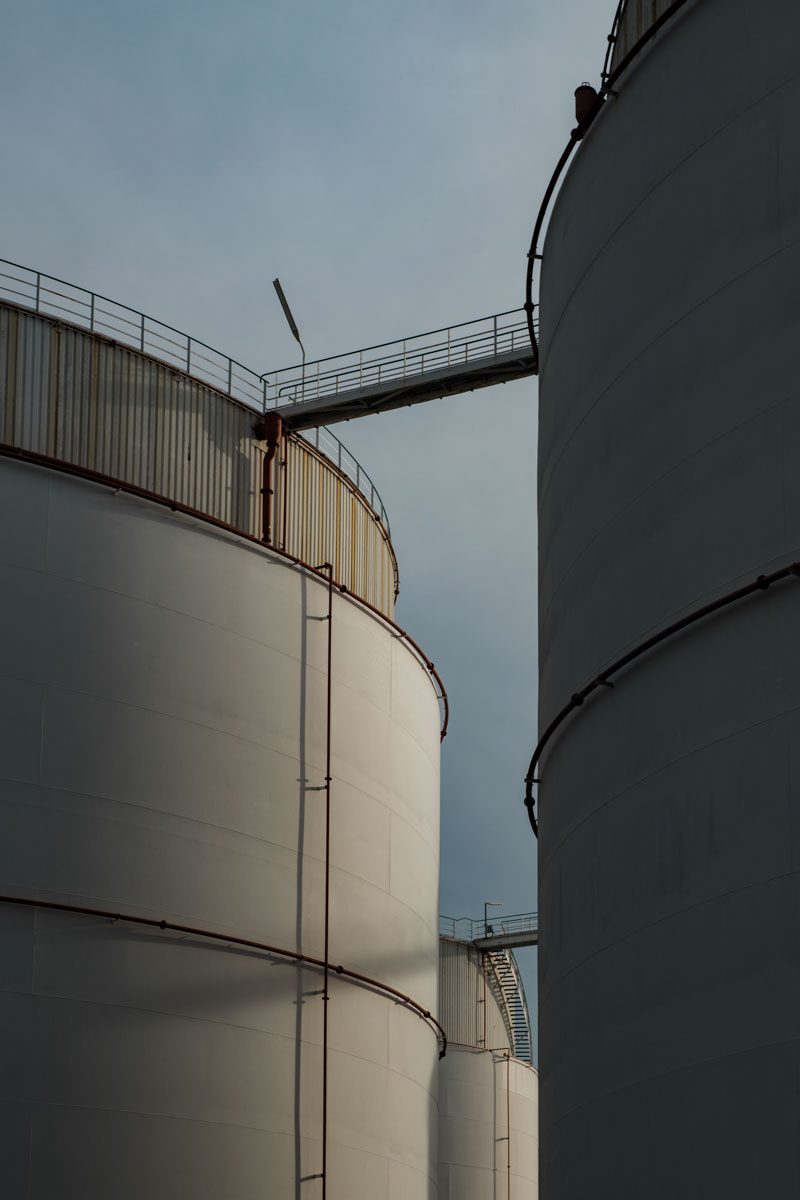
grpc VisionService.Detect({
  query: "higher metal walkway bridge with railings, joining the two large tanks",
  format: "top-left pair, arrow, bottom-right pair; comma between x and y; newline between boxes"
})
263,308 -> 535,430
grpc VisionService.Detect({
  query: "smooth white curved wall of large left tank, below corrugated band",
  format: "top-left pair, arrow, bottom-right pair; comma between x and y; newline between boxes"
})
0,460 -> 439,1200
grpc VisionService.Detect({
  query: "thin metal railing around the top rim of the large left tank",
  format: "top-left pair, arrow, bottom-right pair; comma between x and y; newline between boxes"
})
0,258 -> 391,533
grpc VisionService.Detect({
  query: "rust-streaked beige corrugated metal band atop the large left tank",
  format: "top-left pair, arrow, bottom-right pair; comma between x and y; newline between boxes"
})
0,304 -> 397,617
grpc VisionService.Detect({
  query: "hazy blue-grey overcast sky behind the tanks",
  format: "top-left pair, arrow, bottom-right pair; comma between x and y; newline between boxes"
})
0,0 -> 615,1056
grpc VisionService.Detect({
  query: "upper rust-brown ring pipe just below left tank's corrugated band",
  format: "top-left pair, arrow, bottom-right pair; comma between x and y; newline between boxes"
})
0,443 -> 450,740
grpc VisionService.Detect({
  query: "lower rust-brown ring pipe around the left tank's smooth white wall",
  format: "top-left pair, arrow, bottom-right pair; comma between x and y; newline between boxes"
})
0,894 -> 447,1058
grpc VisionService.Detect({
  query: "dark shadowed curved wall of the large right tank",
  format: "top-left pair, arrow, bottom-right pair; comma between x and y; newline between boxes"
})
539,0 -> 800,1200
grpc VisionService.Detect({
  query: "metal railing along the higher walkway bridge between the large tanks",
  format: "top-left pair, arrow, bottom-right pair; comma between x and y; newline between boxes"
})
265,308 -> 530,409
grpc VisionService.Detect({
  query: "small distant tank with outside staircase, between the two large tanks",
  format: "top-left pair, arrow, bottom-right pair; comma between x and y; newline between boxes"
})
439,936 -> 539,1200
